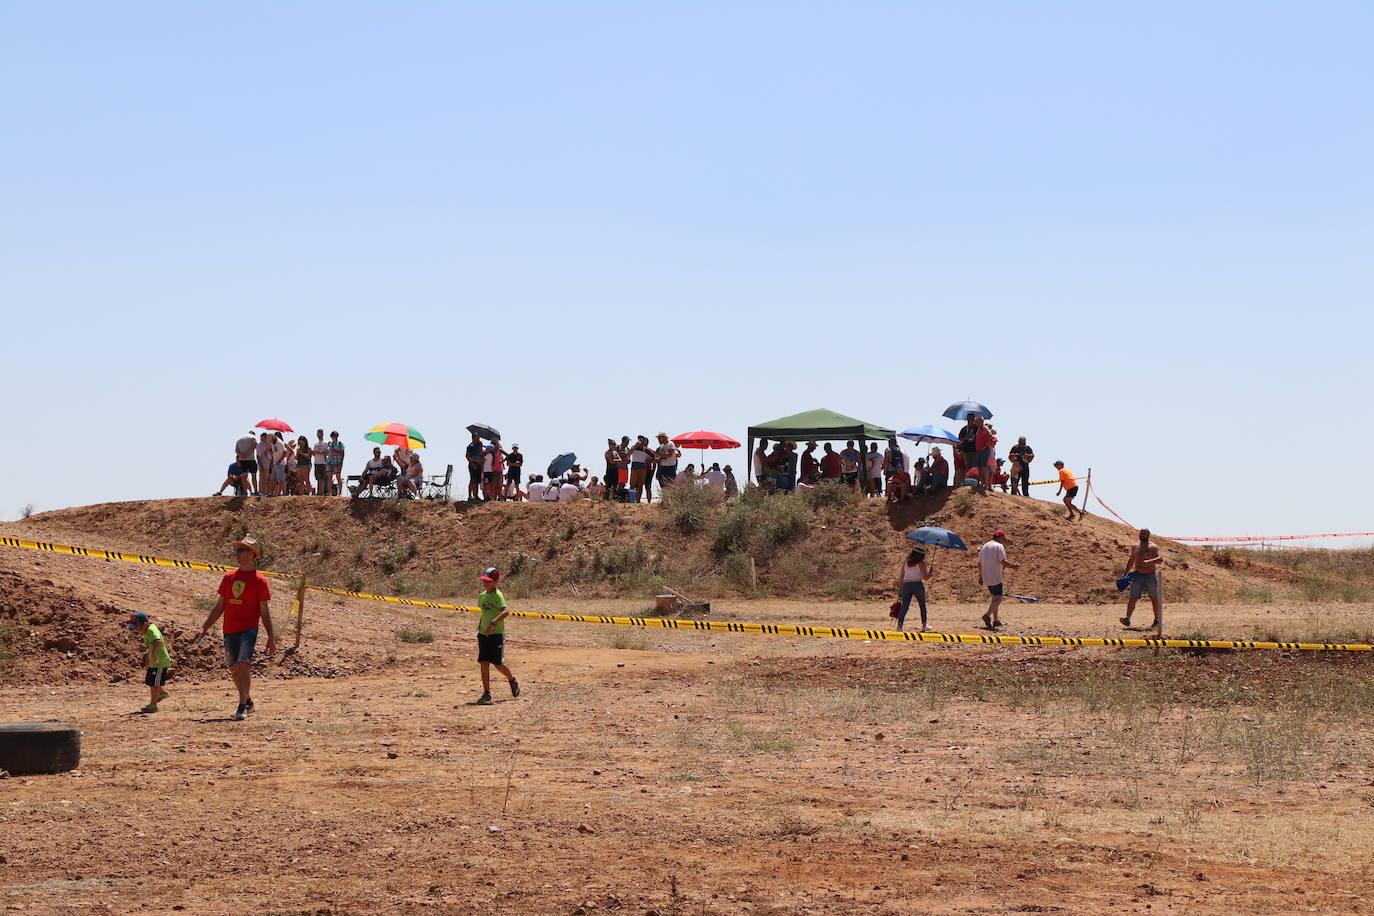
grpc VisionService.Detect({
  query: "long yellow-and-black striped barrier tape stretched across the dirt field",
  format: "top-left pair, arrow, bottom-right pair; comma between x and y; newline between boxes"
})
0,537 -> 1374,652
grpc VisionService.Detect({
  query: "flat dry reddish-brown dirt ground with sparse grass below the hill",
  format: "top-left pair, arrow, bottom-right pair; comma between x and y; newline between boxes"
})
0,532 -> 1374,916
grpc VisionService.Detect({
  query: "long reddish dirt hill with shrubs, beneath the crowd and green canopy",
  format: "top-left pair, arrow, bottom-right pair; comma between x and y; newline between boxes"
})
8,483 -> 1290,602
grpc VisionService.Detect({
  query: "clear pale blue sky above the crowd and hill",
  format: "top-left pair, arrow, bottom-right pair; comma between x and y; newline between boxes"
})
0,1 -> 1374,534
